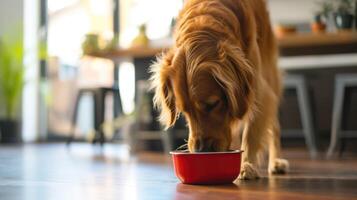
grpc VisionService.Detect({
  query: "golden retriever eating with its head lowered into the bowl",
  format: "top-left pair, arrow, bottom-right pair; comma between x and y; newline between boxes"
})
151,0 -> 288,179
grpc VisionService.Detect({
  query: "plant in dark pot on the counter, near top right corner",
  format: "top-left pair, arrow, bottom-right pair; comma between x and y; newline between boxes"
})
334,0 -> 354,29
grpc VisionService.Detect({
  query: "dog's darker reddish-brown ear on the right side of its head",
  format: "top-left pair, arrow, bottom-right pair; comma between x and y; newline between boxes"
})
217,42 -> 255,119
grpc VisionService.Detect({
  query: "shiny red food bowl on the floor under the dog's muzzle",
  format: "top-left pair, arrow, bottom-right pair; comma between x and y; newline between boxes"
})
170,150 -> 243,184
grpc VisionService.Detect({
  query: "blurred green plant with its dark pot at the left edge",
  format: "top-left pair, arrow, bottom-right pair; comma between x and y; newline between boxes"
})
0,34 -> 24,143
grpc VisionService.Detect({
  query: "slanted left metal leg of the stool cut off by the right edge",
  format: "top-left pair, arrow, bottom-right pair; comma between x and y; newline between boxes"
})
327,80 -> 345,158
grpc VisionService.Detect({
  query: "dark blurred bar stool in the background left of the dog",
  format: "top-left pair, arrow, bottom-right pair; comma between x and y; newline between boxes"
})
67,87 -> 123,145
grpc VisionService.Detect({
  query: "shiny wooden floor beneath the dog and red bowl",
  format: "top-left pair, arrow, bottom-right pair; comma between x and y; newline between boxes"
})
0,144 -> 357,200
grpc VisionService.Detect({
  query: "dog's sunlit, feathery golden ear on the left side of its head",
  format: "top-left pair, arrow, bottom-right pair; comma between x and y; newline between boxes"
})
150,51 -> 178,129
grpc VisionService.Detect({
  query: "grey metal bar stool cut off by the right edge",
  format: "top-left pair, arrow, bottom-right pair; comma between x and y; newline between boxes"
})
326,74 -> 357,158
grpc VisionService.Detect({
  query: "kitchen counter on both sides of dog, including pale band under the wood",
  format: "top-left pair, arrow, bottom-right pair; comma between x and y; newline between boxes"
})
91,31 -> 357,69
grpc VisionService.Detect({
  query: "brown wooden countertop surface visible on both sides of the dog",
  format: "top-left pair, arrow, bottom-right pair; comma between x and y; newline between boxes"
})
91,31 -> 357,60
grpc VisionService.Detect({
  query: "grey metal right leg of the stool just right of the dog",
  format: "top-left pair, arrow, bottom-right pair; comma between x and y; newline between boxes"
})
296,78 -> 317,158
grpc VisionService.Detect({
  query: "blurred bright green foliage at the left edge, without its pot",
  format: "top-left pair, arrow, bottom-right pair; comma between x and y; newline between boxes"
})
0,34 -> 24,119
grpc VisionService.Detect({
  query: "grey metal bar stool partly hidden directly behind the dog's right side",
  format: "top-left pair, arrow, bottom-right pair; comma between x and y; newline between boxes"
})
284,75 -> 317,158
